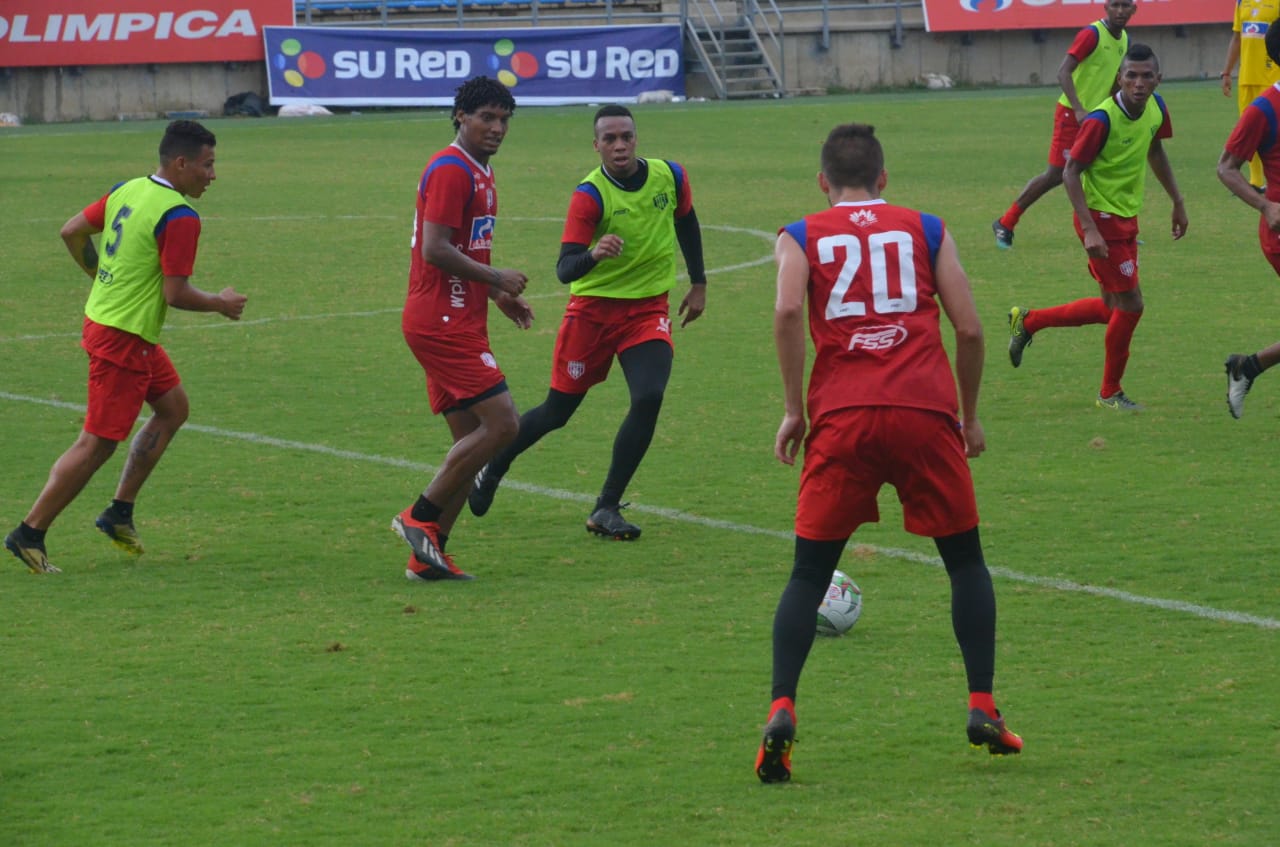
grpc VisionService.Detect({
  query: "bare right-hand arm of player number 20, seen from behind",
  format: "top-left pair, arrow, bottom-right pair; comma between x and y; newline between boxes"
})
933,232 -> 987,458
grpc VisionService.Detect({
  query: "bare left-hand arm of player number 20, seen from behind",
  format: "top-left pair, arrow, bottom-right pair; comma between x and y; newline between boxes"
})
773,233 -> 809,464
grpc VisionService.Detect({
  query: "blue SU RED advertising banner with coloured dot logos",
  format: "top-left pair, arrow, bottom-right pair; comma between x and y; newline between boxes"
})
264,24 -> 685,106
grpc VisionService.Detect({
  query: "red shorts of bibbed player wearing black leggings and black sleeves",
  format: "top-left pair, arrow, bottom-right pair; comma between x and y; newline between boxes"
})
552,294 -> 671,394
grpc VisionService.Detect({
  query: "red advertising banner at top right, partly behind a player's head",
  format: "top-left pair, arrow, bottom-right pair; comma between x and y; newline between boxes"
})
924,0 -> 1235,37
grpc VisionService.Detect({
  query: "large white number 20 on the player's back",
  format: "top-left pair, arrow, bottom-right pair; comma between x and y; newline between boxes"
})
818,230 -> 916,321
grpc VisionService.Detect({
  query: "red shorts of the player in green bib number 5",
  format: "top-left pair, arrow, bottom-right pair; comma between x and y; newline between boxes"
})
81,317 -> 182,441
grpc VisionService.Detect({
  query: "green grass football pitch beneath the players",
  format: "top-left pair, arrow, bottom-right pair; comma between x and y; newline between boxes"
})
0,82 -> 1280,847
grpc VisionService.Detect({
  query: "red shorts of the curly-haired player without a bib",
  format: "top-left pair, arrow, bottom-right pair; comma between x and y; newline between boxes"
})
404,330 -> 507,415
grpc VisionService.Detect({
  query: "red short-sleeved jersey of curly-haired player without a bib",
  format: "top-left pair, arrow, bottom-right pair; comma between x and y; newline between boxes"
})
402,145 -> 498,334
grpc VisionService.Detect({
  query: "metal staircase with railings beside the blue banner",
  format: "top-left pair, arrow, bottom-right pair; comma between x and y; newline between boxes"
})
682,0 -> 786,100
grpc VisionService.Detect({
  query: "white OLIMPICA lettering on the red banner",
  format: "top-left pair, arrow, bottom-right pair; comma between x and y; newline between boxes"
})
0,9 -> 257,44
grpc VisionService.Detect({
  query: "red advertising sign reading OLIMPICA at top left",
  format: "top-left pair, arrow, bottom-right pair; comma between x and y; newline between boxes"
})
0,0 -> 293,68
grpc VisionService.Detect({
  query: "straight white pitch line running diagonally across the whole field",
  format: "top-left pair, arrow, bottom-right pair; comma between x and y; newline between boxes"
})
0,392 -> 1280,629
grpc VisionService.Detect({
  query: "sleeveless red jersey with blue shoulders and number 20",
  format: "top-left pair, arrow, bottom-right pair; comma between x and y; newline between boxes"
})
780,200 -> 959,420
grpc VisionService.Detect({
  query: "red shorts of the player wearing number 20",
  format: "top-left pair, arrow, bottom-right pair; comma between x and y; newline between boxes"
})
796,406 -> 978,541
